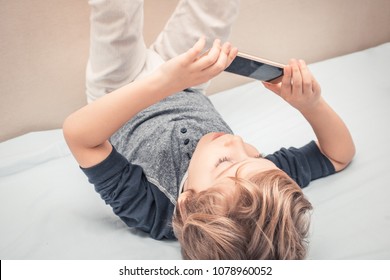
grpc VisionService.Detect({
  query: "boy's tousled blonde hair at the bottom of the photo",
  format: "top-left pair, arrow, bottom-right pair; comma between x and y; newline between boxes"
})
173,170 -> 312,260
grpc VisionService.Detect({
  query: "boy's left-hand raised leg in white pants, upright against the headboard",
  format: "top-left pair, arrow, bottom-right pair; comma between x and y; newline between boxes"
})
86,0 -> 147,102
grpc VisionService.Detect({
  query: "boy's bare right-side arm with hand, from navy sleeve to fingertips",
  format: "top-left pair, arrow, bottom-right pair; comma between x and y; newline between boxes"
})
264,60 -> 355,171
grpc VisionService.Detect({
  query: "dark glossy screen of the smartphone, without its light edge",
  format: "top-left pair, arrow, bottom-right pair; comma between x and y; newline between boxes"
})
225,55 -> 283,82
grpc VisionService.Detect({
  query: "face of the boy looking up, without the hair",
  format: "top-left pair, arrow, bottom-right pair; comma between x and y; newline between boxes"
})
184,132 -> 277,192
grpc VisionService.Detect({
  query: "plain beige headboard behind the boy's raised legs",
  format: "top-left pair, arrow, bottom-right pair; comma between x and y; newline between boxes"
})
0,0 -> 390,141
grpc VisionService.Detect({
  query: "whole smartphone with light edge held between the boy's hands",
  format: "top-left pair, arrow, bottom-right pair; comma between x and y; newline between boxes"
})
225,52 -> 284,84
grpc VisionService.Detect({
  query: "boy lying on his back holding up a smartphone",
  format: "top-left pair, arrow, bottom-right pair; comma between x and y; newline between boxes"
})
63,1 -> 355,259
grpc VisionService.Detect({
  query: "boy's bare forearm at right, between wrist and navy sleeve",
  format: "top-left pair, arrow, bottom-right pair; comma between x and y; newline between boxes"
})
301,98 -> 355,171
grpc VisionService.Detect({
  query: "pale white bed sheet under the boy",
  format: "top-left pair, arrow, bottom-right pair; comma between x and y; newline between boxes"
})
0,43 -> 390,259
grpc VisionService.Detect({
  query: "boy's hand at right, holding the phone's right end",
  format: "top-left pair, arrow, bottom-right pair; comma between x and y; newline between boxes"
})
263,59 -> 321,112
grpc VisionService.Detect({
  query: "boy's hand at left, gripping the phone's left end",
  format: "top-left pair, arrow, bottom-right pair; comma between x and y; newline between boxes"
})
157,38 -> 237,92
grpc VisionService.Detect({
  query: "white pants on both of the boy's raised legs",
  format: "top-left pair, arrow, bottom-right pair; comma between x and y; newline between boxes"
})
86,0 -> 240,102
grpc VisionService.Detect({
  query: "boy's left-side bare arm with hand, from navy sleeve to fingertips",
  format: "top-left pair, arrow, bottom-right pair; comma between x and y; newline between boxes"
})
63,38 -> 237,167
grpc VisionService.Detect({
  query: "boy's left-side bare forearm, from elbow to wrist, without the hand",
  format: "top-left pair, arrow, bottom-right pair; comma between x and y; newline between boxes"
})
64,71 -> 171,151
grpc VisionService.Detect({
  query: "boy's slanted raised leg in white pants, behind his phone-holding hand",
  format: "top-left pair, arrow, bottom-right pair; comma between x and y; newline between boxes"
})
151,0 -> 240,91
